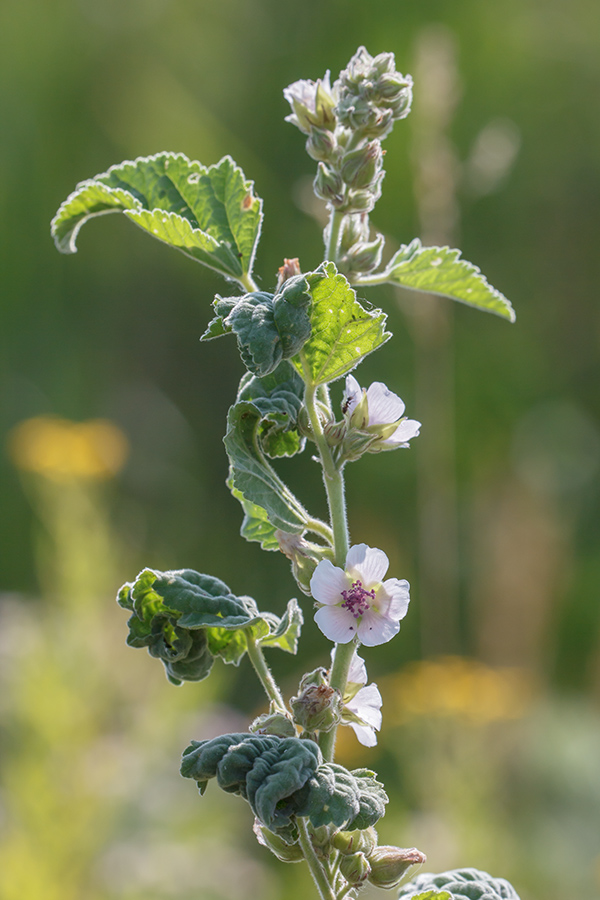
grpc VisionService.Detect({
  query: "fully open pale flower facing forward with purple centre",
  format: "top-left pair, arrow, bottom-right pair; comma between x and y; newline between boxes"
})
310,544 -> 409,647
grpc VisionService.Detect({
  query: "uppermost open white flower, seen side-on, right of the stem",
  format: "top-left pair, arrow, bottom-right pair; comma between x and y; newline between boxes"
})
342,375 -> 421,450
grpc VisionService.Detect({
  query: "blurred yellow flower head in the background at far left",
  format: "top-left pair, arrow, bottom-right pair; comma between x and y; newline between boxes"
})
8,416 -> 129,482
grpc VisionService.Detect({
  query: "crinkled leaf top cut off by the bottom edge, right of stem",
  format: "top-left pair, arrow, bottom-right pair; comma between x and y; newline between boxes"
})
398,869 -> 519,900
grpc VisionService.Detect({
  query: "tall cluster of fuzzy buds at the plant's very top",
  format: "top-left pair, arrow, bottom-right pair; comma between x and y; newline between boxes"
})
283,47 -> 412,275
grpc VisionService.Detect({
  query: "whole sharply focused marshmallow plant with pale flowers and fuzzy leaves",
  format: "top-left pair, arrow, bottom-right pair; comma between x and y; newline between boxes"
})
52,47 -> 516,900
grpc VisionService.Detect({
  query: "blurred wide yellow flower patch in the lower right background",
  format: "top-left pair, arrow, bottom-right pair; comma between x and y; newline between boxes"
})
380,656 -> 533,724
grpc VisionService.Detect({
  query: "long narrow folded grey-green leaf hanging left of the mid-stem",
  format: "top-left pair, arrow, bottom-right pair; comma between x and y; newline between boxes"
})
223,401 -> 309,534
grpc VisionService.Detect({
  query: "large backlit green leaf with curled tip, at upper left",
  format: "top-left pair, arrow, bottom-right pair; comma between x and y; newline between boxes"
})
52,153 -> 262,280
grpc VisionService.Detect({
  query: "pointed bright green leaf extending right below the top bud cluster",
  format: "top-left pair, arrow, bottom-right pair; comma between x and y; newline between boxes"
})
378,238 -> 515,322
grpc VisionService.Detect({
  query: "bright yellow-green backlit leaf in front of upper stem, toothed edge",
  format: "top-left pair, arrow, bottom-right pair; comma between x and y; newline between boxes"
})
294,262 -> 391,385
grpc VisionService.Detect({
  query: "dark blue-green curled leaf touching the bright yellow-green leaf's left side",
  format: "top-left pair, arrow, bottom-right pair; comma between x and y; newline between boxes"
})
201,275 -> 318,377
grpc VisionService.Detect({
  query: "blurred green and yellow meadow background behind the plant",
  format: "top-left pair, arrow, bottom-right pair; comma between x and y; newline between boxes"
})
0,0 -> 600,900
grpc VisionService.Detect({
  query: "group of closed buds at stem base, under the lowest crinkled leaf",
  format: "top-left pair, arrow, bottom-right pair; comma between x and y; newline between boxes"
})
331,828 -> 426,888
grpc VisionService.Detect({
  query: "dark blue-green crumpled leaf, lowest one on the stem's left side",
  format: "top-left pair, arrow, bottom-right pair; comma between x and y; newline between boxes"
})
181,734 -> 323,830
